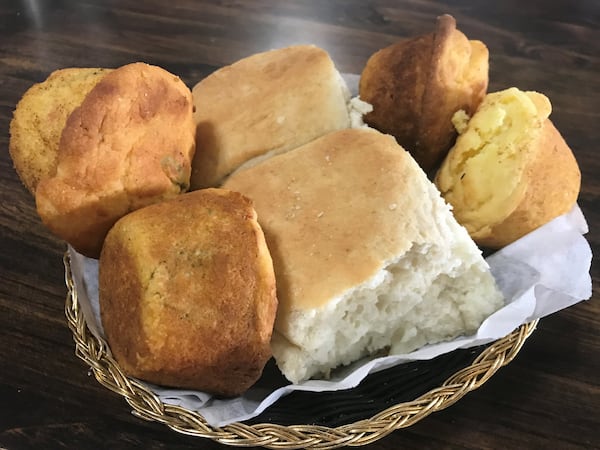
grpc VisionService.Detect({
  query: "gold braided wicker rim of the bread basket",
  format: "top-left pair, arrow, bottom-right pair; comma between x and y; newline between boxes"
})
64,254 -> 537,449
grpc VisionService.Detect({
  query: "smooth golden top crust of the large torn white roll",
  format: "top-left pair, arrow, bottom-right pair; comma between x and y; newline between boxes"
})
224,129 -> 432,320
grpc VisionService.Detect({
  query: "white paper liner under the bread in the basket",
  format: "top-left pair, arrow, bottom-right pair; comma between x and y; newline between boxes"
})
69,206 -> 592,426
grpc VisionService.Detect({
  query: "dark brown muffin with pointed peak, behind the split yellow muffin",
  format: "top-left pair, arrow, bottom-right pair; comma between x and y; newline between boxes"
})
359,15 -> 488,172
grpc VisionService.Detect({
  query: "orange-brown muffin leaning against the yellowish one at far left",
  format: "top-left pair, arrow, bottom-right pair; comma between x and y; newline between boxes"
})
35,63 -> 195,258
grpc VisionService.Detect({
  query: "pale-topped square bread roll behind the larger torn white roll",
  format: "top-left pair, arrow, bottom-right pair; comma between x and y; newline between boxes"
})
191,45 -> 350,189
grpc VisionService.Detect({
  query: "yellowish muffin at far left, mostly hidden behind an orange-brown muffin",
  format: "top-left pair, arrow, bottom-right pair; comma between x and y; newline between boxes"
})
9,68 -> 110,194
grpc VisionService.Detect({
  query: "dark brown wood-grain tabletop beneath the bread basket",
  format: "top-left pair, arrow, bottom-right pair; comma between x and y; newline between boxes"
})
0,0 -> 600,450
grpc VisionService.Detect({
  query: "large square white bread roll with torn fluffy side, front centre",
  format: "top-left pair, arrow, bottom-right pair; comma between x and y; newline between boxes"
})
224,128 -> 502,382
